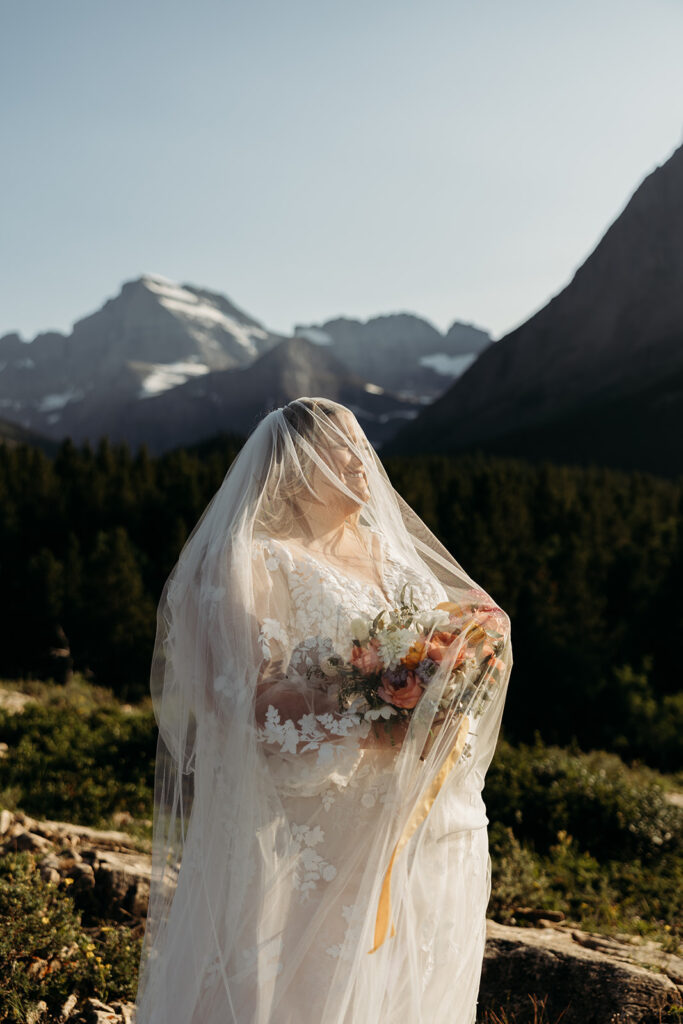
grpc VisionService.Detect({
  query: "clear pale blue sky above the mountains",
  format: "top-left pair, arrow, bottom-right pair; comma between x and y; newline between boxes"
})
0,0 -> 683,338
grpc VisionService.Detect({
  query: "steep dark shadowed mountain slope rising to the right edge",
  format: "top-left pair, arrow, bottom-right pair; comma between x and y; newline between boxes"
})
387,145 -> 683,468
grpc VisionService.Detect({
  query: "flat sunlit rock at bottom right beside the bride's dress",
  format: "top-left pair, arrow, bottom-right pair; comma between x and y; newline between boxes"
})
479,921 -> 683,1024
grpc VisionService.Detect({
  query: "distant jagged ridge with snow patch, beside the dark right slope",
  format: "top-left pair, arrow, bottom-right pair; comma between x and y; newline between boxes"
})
295,313 -> 490,402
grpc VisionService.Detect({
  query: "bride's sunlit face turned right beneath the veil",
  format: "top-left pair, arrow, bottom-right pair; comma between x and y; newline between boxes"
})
310,414 -> 370,515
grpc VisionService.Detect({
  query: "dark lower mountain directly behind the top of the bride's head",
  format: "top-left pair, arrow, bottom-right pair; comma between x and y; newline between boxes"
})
57,337 -> 416,454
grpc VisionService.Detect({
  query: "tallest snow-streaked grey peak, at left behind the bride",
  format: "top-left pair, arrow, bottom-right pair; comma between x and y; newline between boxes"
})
0,274 -> 283,437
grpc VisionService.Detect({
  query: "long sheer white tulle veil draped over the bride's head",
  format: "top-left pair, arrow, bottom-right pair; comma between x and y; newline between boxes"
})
137,398 -> 512,1024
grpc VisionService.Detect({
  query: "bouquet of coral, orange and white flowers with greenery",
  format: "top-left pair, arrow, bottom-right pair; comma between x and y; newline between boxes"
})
319,584 -> 506,725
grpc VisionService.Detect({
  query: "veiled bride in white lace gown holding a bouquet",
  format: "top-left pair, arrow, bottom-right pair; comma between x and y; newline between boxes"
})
136,398 -> 512,1024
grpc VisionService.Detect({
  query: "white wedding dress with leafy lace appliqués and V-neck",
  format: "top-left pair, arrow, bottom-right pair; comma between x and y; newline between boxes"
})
138,399 -> 507,1024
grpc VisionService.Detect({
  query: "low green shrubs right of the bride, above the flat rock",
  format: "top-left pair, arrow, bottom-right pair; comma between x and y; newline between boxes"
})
484,738 -> 683,951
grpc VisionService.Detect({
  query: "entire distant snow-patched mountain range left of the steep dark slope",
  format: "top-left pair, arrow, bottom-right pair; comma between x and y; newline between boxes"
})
0,274 -> 490,450
